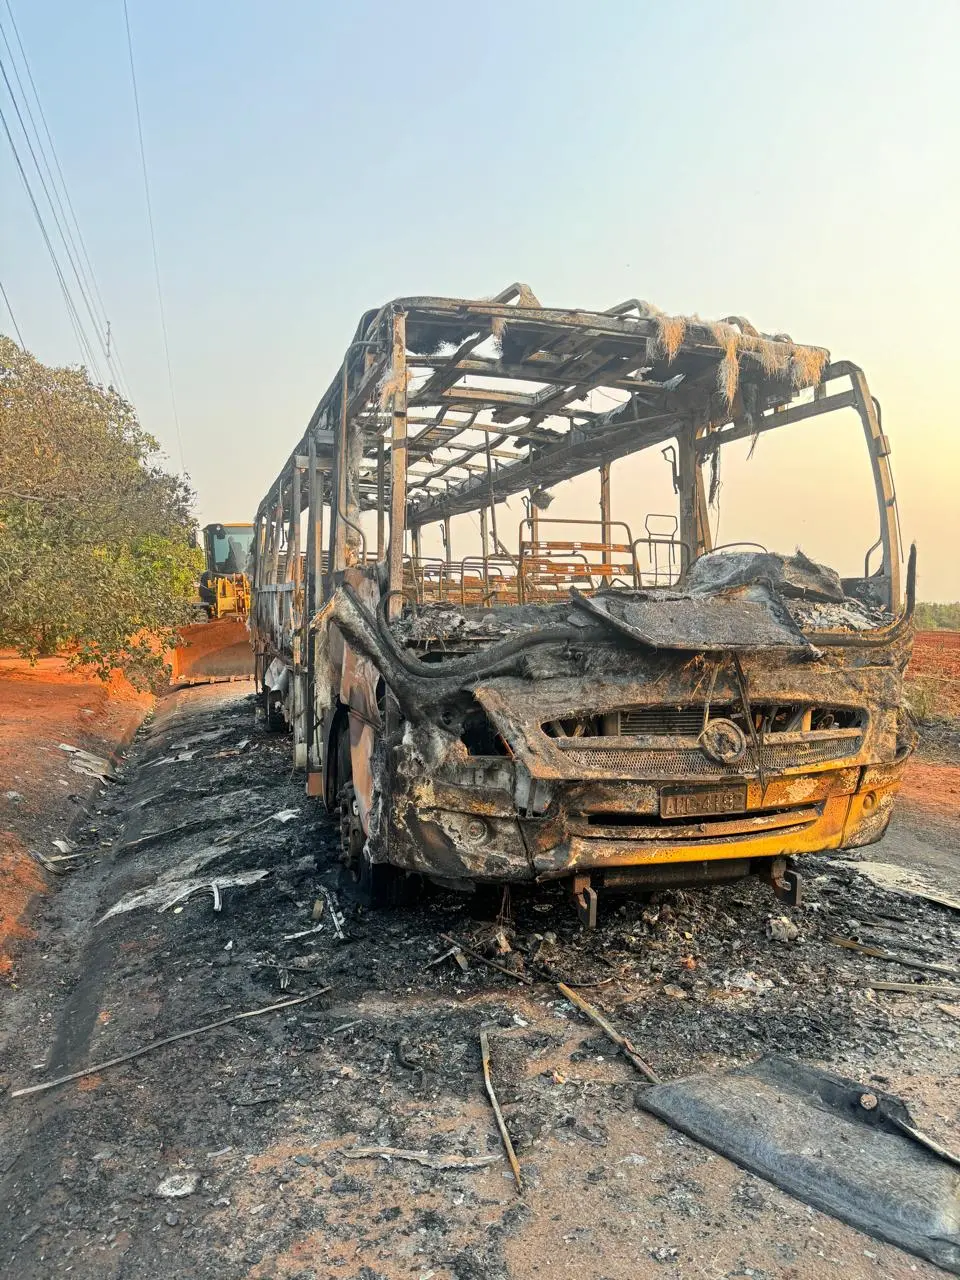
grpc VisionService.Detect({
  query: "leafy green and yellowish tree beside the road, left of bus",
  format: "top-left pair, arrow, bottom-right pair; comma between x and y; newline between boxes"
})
0,335 -> 202,685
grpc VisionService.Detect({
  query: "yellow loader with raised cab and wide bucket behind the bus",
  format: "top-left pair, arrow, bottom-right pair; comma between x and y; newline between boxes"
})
172,524 -> 253,685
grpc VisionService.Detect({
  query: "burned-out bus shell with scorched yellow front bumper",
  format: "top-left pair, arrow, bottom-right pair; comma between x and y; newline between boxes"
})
251,284 -> 915,923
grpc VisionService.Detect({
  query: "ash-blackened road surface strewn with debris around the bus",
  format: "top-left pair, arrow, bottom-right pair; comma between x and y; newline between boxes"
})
0,685 -> 960,1280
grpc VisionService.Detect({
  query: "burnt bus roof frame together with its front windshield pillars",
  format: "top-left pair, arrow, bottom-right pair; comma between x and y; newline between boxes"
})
257,284 -> 900,607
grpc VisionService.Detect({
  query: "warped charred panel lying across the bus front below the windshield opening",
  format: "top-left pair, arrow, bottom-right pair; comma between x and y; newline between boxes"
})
571,584 -> 812,653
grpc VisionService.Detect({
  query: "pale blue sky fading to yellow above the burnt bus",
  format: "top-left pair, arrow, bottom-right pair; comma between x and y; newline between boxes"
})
0,0 -> 960,600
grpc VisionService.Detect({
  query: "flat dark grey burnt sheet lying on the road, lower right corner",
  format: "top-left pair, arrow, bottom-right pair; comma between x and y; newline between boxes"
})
639,1056 -> 960,1275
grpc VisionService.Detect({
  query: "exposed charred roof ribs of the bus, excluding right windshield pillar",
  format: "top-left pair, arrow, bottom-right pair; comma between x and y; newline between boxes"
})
261,284 -> 828,526
